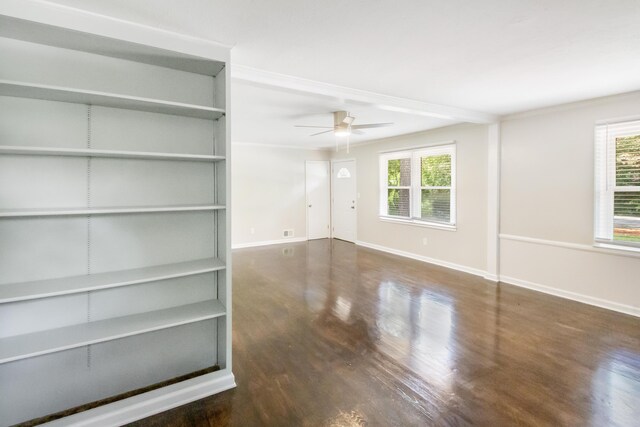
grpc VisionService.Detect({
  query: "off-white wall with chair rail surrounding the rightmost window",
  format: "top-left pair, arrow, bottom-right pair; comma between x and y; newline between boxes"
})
500,93 -> 640,315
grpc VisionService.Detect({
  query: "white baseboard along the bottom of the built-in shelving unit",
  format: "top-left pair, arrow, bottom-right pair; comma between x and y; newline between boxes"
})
43,369 -> 236,427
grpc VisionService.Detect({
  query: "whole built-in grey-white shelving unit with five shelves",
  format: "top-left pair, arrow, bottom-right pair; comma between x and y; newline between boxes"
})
0,0 -> 235,427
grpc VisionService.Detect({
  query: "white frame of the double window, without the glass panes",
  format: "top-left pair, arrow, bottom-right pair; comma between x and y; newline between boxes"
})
379,142 -> 457,230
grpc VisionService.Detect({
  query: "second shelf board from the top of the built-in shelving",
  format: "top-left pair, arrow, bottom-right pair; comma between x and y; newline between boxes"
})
0,145 -> 225,162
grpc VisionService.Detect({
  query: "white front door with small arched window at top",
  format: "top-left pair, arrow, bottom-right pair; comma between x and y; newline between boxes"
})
331,160 -> 357,242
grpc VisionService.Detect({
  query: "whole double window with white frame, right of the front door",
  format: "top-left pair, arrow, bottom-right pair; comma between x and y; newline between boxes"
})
380,144 -> 456,226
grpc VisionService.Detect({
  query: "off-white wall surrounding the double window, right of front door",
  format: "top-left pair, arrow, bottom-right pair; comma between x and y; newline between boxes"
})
334,125 -> 488,275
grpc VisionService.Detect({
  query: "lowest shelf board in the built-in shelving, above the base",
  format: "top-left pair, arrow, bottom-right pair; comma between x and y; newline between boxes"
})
0,300 -> 226,363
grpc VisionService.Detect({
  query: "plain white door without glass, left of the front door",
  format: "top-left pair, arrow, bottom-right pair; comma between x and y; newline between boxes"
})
306,160 -> 331,239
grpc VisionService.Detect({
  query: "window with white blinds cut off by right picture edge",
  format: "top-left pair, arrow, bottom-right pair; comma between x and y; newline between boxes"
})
595,120 -> 640,248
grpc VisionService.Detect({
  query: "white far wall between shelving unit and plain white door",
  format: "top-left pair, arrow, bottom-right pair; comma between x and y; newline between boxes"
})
231,143 -> 330,247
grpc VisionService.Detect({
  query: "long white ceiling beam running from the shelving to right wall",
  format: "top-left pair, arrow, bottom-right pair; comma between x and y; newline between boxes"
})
231,62 -> 498,124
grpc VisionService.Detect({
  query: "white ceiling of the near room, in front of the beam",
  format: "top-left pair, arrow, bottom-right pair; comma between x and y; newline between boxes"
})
42,0 -> 640,145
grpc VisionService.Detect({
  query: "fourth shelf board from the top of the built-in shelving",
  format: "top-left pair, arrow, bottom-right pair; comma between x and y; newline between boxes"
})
0,258 -> 225,304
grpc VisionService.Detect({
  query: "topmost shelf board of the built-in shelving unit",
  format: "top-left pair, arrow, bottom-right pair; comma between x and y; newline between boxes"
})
0,80 -> 224,120
